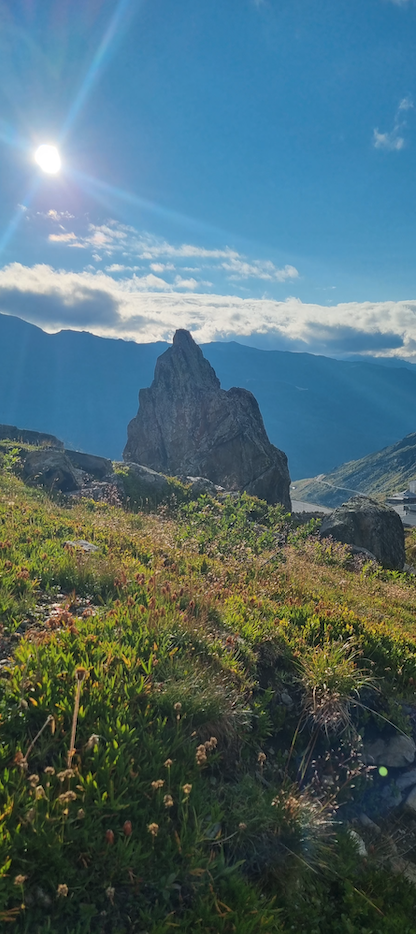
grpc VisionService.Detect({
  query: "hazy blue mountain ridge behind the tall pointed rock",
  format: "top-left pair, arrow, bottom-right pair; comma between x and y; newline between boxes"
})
0,315 -> 416,478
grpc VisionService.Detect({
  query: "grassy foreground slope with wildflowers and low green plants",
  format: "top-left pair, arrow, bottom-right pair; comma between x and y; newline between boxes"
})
0,470 -> 416,934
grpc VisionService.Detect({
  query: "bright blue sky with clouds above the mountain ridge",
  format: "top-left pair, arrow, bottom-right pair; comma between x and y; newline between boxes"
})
0,0 -> 416,362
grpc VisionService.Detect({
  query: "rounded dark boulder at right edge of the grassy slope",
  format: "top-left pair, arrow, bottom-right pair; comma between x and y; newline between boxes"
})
319,496 -> 405,570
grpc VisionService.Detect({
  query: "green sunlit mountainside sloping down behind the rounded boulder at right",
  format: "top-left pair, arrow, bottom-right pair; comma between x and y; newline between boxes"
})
292,432 -> 416,507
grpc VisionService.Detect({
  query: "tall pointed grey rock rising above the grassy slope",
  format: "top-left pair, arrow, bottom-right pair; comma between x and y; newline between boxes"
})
123,330 -> 290,509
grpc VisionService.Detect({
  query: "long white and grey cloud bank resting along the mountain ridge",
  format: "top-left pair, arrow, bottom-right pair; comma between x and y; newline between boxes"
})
0,263 -> 416,362
